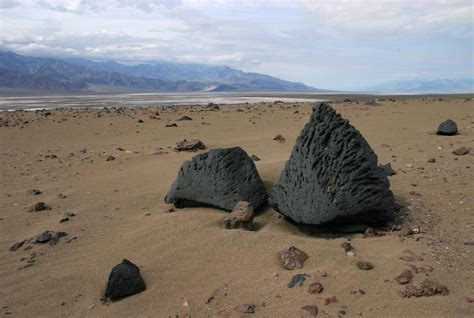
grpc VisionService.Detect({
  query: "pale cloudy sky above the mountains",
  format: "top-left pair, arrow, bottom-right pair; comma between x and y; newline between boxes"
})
0,0 -> 474,89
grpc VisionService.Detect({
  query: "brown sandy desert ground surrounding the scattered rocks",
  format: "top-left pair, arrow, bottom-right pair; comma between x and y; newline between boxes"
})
0,97 -> 474,317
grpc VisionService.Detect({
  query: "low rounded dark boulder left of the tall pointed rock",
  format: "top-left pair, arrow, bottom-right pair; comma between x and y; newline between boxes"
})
165,147 -> 268,211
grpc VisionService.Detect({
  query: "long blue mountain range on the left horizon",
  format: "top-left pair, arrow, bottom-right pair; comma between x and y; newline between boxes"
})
0,51 -> 318,92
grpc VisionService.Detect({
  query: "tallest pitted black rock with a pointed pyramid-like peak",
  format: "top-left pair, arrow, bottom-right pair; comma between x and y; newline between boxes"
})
270,103 -> 394,224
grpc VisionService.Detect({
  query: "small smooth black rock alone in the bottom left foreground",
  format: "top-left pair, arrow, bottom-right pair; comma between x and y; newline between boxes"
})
105,259 -> 146,300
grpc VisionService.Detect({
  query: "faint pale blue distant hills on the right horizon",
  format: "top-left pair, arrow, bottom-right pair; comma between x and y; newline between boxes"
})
367,78 -> 474,93
